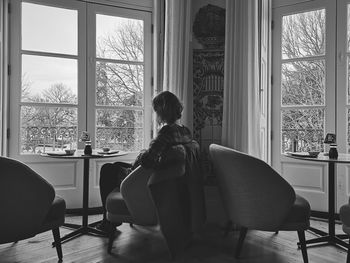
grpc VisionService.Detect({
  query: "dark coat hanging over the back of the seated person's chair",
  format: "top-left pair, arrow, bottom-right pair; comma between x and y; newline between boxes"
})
148,143 -> 200,255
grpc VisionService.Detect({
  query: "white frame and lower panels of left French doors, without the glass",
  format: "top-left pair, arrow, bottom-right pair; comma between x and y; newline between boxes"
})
8,0 -> 153,208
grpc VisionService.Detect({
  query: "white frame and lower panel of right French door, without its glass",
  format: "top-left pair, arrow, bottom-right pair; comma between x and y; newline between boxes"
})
272,0 -> 336,211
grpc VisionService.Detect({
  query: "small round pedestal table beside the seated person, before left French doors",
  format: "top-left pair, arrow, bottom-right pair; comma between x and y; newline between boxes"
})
41,150 -> 127,245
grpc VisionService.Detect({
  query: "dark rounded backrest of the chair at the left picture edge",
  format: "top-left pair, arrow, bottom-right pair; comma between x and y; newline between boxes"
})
0,157 -> 55,243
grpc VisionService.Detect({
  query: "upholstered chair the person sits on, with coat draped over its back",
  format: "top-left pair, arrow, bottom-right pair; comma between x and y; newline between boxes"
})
106,141 -> 205,258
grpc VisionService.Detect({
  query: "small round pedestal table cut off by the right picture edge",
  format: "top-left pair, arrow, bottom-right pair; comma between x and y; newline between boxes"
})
284,153 -> 350,249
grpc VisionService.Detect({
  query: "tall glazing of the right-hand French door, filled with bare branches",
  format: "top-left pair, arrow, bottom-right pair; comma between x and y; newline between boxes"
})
280,9 -> 326,152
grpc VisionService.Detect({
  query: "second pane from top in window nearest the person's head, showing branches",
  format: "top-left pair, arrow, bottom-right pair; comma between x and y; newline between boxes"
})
96,62 -> 144,106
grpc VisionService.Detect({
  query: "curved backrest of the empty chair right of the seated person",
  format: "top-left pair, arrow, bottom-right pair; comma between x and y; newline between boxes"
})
209,144 -> 295,231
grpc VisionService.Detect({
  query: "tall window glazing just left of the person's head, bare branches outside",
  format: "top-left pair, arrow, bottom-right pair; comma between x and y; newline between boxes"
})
95,14 -> 144,151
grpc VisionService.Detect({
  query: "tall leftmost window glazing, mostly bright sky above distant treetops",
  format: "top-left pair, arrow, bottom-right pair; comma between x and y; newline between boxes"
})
19,2 -> 78,154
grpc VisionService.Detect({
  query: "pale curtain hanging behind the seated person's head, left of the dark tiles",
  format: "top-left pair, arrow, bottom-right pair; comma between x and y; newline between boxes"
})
163,0 -> 192,128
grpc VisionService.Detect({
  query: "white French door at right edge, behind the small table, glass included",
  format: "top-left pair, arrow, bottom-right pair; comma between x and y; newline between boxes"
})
272,0 -> 350,211
